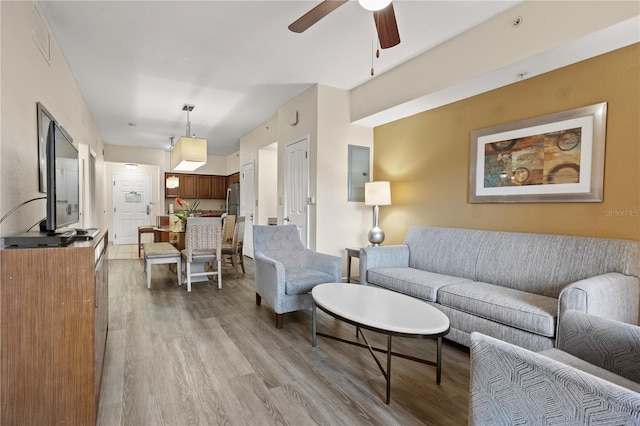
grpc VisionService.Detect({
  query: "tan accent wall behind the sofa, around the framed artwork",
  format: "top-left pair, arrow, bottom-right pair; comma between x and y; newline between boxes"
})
374,44 -> 640,244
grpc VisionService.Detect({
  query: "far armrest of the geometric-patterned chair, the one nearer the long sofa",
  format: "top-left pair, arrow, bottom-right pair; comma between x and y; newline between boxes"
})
556,310 -> 640,383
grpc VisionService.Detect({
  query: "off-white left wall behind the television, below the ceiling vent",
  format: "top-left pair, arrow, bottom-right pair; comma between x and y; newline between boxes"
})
0,1 -> 105,236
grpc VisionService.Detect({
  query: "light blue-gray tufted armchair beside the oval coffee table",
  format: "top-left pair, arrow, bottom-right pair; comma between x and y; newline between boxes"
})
253,225 -> 342,328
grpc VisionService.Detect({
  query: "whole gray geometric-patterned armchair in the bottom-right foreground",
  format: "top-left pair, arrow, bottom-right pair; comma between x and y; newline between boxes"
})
469,310 -> 640,426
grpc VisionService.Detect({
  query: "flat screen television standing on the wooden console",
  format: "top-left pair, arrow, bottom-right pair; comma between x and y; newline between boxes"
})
40,121 -> 80,234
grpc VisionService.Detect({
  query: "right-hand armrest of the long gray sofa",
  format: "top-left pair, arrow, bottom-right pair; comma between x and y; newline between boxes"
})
558,272 -> 640,325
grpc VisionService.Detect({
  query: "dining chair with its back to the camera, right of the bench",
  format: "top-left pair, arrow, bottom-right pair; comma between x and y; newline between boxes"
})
181,217 -> 222,292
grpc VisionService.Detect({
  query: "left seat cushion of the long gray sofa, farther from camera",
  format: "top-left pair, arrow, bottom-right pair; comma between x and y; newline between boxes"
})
367,268 -> 472,302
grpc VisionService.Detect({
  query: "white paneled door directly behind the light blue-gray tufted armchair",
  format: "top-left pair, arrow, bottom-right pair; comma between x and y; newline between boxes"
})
284,136 -> 309,248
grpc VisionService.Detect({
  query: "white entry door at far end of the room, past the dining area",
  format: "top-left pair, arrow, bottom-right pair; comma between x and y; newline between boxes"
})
113,173 -> 155,244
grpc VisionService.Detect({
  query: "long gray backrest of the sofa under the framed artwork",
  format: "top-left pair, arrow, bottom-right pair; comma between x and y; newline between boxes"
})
405,226 -> 640,298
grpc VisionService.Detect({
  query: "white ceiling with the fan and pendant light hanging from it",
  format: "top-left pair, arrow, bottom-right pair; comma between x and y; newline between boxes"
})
41,0 -> 520,155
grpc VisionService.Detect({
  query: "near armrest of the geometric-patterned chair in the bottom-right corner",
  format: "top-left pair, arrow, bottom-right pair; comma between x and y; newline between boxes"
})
469,332 -> 640,425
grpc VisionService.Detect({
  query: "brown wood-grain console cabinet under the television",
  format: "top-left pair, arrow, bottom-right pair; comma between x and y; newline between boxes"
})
0,231 -> 109,425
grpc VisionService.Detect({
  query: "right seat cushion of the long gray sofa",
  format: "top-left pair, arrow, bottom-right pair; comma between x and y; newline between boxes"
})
438,282 -> 558,337
